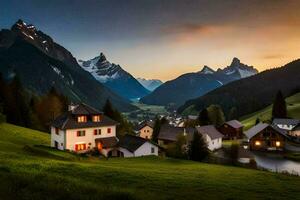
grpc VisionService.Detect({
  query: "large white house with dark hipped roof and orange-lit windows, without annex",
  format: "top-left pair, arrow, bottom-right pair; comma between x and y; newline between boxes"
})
51,103 -> 118,153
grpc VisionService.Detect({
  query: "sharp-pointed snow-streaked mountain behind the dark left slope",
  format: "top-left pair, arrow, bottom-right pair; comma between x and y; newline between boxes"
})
78,53 -> 150,99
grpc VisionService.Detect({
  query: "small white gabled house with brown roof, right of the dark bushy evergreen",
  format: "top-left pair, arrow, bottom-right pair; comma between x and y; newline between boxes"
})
196,125 -> 224,151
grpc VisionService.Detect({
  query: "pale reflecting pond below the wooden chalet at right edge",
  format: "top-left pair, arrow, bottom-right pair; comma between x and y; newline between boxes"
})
253,152 -> 300,175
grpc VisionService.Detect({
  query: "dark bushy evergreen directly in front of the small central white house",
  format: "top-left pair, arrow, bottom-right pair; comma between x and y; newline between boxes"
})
189,131 -> 208,161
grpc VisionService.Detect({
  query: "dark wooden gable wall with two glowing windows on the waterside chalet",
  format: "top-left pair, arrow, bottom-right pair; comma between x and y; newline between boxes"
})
250,127 -> 285,150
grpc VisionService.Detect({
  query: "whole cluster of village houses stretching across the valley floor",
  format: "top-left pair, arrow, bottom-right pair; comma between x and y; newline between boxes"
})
51,103 -> 300,173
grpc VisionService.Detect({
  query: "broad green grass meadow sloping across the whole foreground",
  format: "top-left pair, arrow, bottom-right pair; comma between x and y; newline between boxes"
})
0,124 -> 300,200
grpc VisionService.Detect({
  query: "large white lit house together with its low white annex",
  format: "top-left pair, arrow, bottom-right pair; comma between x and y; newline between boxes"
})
51,104 -> 162,157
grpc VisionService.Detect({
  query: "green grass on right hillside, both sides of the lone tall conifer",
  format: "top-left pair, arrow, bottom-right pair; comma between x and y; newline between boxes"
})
241,93 -> 300,130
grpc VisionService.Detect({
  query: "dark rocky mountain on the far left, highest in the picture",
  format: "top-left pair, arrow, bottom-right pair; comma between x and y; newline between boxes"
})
0,20 -> 135,111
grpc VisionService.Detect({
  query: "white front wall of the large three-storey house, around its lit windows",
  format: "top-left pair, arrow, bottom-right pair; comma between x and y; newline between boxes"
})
65,126 -> 116,151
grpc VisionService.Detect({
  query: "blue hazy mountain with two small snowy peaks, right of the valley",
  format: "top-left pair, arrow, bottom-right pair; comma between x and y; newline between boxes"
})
141,58 -> 258,107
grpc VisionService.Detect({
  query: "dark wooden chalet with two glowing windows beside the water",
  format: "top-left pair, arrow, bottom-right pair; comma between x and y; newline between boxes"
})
245,123 -> 287,150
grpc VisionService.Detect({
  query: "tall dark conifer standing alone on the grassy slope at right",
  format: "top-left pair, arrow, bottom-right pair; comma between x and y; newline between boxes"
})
272,90 -> 287,119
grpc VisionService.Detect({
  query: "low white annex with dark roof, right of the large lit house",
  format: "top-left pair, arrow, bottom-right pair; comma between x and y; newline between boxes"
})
118,135 -> 161,158
